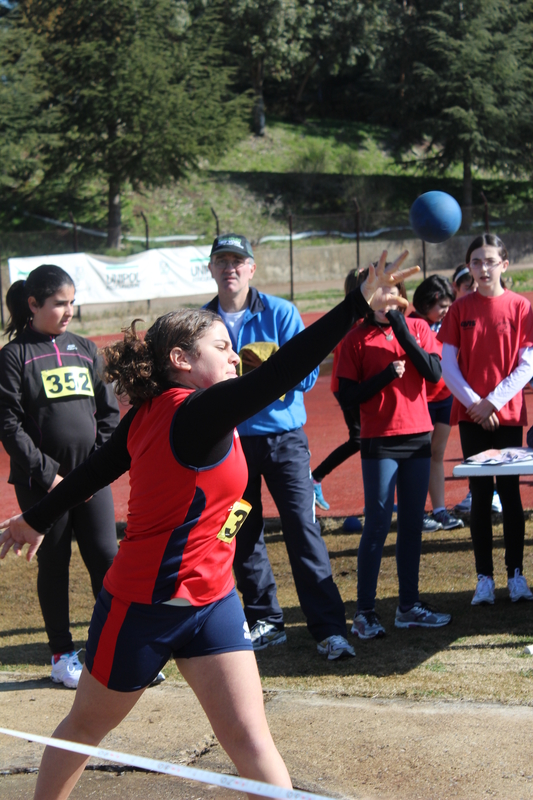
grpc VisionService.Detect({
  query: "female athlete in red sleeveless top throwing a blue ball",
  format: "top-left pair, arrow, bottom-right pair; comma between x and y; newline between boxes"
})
0,253 -> 418,800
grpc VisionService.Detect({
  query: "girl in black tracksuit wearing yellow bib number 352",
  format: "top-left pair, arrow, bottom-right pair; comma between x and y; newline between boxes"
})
0,265 -> 119,689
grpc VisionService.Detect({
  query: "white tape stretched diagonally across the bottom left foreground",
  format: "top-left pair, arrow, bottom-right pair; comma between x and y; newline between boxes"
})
0,728 -> 331,800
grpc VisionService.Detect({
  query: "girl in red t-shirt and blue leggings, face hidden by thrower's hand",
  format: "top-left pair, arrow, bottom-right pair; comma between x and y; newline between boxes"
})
337,272 -> 451,639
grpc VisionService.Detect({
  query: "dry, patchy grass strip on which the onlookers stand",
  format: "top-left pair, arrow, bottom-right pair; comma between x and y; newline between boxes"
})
0,518 -> 533,705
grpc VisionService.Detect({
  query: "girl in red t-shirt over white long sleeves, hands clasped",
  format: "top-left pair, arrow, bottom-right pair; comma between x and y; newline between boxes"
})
438,233 -> 533,605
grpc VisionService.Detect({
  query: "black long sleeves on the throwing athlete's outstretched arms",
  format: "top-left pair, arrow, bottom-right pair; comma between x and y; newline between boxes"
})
24,289 -> 369,532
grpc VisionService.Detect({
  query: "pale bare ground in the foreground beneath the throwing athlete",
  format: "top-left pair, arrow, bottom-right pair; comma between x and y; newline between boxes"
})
0,667 -> 533,800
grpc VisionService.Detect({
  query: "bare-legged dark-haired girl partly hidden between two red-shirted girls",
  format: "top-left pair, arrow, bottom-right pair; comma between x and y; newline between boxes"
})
413,275 -> 463,531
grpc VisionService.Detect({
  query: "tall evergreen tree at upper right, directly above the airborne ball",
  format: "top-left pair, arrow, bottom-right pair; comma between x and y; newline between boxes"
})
374,0 -> 530,213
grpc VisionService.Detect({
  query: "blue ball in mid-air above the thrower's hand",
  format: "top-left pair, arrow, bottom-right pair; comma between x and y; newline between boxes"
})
409,192 -> 462,244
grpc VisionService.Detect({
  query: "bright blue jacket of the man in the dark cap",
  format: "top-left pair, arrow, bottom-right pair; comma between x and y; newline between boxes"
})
205,287 -> 318,436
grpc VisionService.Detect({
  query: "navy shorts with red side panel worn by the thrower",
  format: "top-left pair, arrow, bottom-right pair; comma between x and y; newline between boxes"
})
85,589 -> 253,692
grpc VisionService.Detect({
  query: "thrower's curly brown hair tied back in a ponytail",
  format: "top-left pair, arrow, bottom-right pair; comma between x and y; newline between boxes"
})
102,308 -> 222,406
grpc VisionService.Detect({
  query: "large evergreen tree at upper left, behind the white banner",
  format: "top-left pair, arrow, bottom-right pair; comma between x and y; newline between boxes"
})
0,0 -> 249,247
